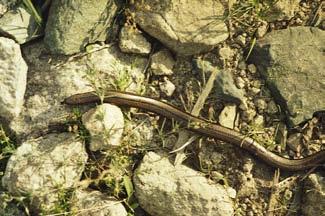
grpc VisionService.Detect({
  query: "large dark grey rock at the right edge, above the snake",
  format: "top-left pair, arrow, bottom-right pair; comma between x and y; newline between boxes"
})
250,27 -> 325,127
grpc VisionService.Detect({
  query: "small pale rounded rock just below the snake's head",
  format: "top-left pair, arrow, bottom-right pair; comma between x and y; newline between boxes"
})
82,104 -> 124,151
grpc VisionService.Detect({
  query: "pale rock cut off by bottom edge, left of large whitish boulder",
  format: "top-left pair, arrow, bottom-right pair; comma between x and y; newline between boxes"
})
71,189 -> 127,216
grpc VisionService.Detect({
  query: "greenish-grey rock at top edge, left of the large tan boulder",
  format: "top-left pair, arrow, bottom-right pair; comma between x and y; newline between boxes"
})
44,0 -> 118,55
